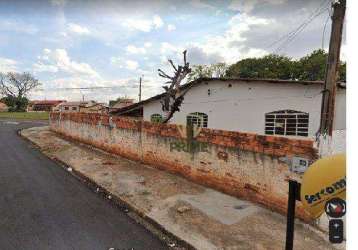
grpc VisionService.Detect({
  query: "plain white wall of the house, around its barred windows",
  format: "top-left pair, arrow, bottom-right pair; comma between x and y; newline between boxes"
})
143,81 -> 345,136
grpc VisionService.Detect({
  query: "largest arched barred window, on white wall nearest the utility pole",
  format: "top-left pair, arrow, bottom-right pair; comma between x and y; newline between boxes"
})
265,110 -> 309,136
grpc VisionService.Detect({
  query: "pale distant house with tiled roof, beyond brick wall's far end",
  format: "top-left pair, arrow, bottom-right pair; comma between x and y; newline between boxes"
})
55,101 -> 108,113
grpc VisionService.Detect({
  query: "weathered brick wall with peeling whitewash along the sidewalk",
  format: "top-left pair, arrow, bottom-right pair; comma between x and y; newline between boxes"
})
50,113 -> 317,220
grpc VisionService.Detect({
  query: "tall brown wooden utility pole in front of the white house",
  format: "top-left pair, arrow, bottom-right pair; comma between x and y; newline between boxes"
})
320,0 -> 346,136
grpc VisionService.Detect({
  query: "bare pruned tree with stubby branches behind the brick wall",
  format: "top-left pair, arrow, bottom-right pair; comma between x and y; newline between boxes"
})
158,50 -> 191,123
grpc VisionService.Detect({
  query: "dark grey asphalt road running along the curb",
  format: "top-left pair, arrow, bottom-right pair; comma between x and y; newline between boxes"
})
0,120 -> 167,250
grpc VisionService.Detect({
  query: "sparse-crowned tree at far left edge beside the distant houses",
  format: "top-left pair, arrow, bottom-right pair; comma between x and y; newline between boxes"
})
0,72 -> 41,111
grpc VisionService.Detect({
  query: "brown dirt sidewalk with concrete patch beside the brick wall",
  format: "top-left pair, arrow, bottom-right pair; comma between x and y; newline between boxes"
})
21,127 -> 334,250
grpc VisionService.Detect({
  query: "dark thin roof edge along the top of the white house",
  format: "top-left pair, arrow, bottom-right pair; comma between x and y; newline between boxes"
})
110,77 -> 346,114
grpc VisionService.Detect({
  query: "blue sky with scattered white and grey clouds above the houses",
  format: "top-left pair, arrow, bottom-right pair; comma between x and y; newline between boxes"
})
0,0 -> 346,102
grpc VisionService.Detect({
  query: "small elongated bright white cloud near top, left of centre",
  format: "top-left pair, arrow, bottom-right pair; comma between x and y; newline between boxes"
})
122,15 -> 164,32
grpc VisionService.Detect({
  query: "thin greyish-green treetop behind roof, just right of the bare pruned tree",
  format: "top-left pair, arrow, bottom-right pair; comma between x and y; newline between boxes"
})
188,63 -> 228,82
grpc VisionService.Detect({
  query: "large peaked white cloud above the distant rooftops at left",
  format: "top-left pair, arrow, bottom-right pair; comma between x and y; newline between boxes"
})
33,49 -> 99,77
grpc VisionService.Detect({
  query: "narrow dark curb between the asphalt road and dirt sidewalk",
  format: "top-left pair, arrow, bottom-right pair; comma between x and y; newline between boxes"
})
17,129 -> 196,250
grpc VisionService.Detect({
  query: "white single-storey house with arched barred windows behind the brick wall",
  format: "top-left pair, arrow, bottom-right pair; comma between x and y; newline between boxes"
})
112,78 -> 346,137
